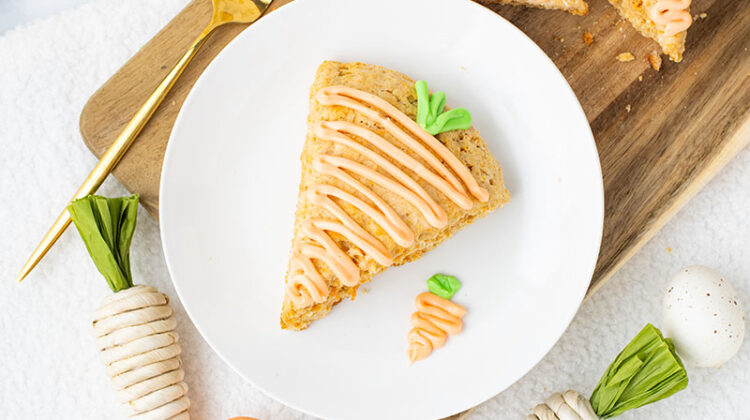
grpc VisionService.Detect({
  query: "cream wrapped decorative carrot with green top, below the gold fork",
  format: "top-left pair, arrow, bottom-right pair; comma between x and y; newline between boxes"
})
68,195 -> 190,420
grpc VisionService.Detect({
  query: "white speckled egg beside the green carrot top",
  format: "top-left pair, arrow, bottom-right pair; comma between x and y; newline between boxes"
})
663,265 -> 745,367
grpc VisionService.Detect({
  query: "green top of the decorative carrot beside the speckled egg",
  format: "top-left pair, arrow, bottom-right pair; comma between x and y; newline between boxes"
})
590,324 -> 688,419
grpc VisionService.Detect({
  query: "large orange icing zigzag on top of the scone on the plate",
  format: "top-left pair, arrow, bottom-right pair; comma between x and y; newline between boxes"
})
286,86 -> 489,307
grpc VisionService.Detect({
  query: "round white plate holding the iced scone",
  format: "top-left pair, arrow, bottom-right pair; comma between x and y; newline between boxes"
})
160,0 -> 603,419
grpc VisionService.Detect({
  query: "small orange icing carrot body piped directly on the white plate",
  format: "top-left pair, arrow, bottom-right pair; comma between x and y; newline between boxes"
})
407,292 -> 466,363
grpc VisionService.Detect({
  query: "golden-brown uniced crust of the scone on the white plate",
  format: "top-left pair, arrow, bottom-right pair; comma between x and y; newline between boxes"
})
281,61 -> 510,330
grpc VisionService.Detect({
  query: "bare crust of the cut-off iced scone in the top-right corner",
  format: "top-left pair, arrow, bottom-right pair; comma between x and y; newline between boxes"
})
609,0 -> 692,62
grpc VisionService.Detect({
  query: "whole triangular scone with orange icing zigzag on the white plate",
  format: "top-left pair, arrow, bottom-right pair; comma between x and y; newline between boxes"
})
281,61 -> 510,330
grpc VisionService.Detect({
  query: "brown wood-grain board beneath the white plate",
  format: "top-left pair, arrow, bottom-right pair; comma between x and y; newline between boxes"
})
81,0 -> 750,416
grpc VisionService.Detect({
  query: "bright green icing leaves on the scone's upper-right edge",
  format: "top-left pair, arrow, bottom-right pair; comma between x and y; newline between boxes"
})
414,80 -> 471,136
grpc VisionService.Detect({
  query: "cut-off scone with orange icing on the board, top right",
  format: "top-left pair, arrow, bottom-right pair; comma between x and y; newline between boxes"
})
609,0 -> 692,62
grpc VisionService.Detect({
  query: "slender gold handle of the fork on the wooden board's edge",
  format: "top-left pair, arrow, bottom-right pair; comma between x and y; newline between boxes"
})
16,27 -> 216,282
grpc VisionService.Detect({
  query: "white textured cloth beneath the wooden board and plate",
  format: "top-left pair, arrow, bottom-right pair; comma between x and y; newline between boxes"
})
0,0 -> 750,419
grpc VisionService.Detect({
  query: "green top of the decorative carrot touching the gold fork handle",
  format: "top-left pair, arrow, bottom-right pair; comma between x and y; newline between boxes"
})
68,194 -> 138,292
